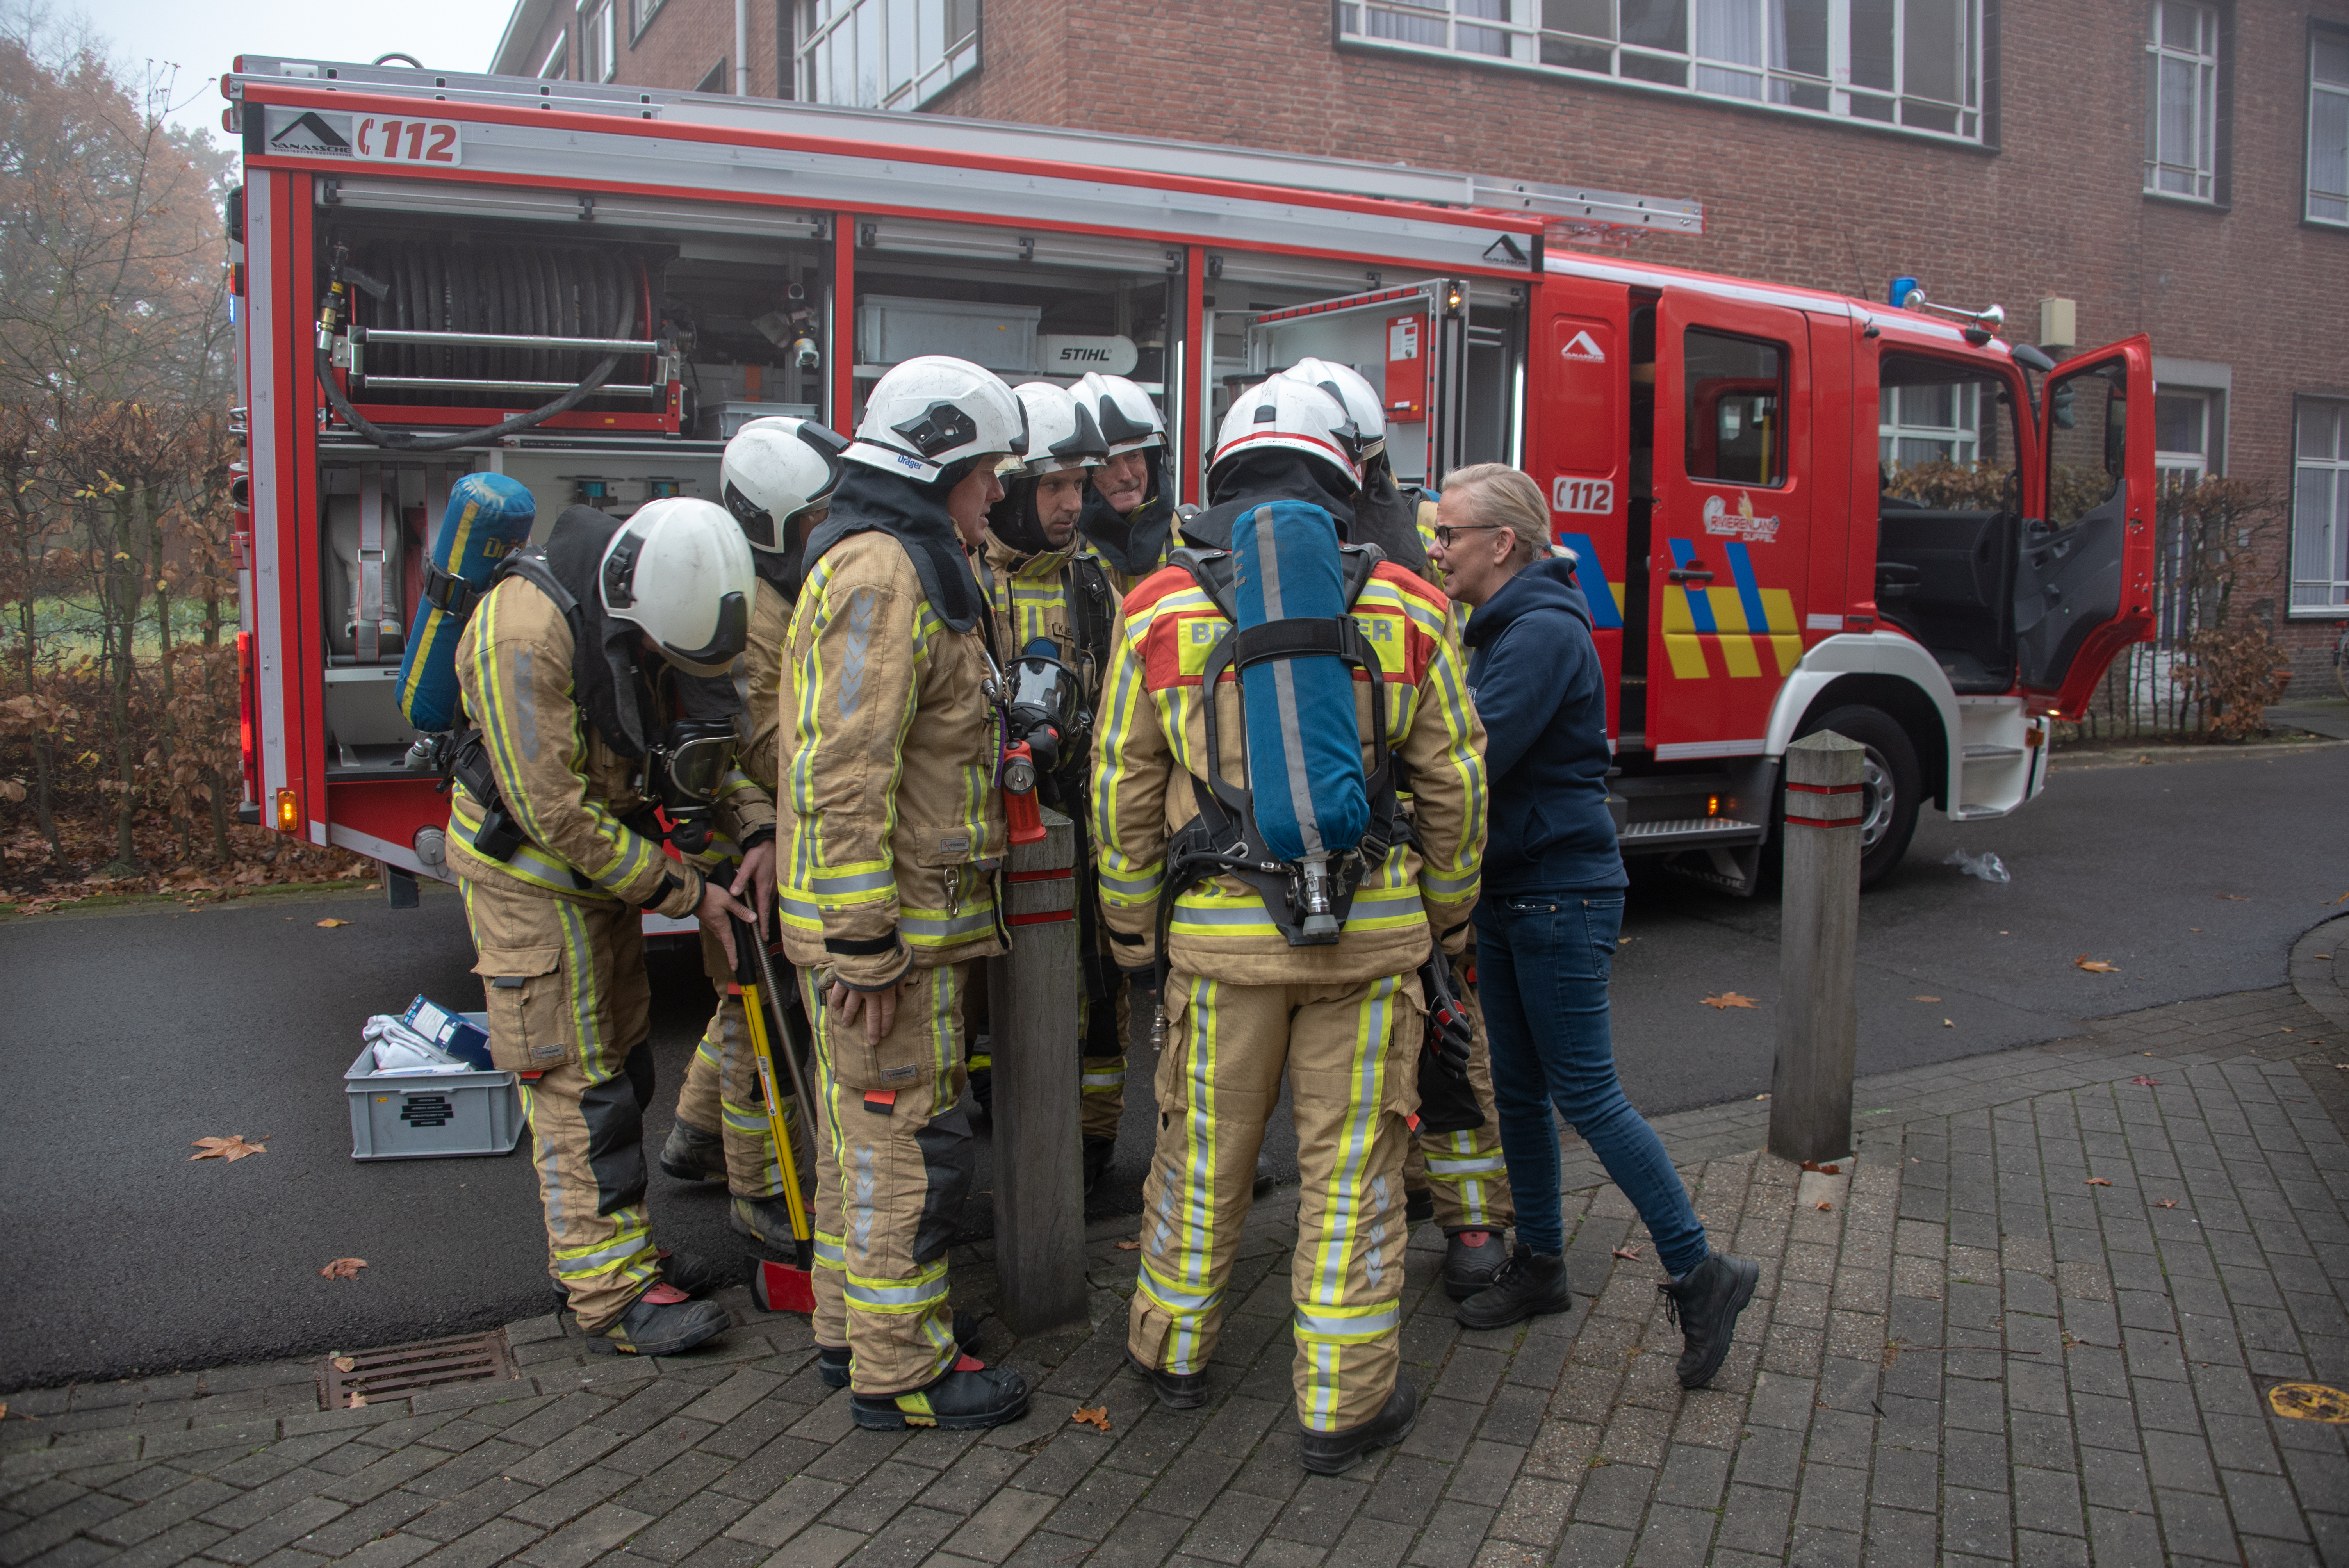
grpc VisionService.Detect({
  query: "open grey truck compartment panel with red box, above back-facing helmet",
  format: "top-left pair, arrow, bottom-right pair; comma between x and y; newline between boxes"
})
1247,277 -> 1468,486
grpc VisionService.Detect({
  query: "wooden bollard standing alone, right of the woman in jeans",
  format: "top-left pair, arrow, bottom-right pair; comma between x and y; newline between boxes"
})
1769,730 -> 1868,1160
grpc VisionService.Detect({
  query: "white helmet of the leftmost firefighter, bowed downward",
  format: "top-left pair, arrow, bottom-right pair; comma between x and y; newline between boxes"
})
597,495 -> 759,676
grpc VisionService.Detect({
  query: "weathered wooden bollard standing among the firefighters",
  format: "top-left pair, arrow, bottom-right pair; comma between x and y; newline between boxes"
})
987,810 -> 1087,1338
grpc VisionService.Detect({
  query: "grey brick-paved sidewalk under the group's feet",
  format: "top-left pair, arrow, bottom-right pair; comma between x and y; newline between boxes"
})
0,988 -> 2349,1568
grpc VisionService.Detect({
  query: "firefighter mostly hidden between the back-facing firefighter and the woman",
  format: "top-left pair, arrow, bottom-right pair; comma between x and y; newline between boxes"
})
1283,359 -> 1517,1301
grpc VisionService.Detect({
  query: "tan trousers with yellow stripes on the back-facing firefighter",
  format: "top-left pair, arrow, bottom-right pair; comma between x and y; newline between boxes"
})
1128,965 -> 1424,1432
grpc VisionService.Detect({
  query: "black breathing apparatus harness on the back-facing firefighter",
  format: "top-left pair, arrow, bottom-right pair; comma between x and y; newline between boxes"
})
1158,545 -> 1412,988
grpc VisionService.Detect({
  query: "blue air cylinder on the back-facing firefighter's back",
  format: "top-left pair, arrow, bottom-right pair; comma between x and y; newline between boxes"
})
1231,500 -> 1369,859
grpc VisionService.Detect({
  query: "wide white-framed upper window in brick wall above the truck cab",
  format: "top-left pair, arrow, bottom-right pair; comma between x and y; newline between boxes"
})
1337,0 -> 1983,141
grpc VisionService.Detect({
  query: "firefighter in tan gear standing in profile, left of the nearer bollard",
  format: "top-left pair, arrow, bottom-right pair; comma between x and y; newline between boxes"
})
782,355 -> 1029,1429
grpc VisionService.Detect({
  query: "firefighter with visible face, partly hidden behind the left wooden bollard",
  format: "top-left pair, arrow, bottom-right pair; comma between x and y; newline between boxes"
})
973,380 -> 1132,1195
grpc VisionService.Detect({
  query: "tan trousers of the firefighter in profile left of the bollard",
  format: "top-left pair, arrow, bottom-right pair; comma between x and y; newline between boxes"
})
798,965 -> 973,1394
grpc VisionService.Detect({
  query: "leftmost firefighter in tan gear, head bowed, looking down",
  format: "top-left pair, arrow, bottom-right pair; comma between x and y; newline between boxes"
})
449,498 -> 775,1354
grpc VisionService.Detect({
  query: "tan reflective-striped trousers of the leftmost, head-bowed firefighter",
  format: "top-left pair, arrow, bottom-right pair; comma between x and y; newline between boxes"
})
458,878 -> 660,1333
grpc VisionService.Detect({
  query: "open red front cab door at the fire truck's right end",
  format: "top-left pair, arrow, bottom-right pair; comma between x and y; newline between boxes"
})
2016,333 -> 2154,718
